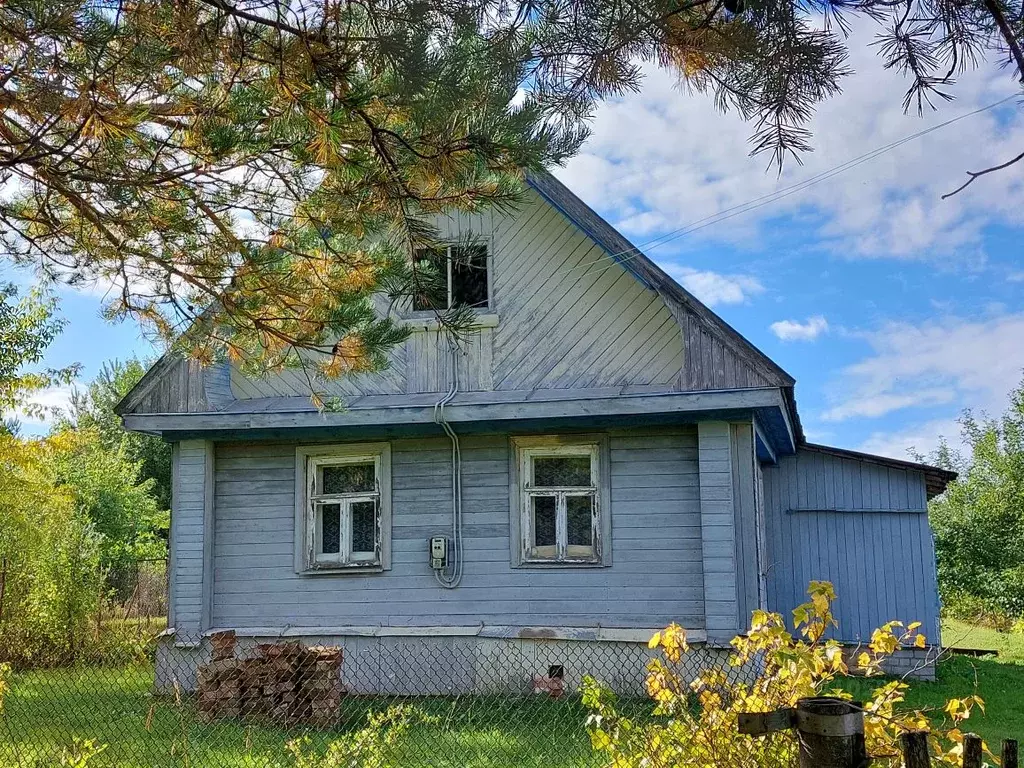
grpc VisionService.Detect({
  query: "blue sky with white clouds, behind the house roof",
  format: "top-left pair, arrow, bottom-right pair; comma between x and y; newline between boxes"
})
12,24 -> 1024,458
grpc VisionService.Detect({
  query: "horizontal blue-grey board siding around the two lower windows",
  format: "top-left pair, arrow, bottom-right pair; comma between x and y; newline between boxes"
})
207,428 -> 704,629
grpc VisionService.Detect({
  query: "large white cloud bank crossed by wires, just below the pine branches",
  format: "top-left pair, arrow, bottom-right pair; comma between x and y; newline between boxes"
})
558,22 -> 1024,266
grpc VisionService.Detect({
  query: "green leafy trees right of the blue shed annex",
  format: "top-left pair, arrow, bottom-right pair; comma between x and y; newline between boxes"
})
929,383 -> 1024,618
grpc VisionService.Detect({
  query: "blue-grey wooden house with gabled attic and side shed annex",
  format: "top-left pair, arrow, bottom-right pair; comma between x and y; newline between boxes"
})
120,175 -> 952,692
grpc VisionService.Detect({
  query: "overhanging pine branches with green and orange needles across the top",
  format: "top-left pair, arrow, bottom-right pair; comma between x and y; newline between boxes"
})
0,0 -> 1024,385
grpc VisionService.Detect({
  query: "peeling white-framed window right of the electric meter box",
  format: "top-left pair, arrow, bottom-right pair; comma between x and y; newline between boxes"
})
512,435 -> 611,565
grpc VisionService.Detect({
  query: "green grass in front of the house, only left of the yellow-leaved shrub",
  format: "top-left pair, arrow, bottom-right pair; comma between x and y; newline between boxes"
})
0,667 -> 598,768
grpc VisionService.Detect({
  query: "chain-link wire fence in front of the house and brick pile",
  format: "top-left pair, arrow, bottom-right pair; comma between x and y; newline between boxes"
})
0,633 -> 790,768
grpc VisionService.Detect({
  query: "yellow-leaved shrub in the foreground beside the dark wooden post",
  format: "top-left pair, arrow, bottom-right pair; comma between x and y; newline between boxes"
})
584,582 -> 987,768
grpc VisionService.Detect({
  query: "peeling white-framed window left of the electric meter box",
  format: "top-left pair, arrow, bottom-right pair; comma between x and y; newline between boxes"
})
295,443 -> 391,572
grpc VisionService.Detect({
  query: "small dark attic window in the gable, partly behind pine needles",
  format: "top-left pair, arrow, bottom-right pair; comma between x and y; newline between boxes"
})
413,244 -> 489,311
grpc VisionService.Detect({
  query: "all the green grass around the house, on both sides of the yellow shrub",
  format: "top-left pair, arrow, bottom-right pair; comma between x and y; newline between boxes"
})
0,622 -> 1024,768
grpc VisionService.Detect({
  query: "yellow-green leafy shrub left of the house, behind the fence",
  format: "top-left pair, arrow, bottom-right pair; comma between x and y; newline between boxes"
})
0,430 -> 167,667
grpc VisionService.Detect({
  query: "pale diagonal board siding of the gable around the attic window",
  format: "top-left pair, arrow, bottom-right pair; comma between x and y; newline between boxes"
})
231,191 -> 683,398
